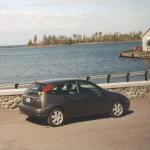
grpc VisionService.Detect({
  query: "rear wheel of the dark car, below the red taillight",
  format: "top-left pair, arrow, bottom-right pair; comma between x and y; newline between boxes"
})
47,108 -> 64,127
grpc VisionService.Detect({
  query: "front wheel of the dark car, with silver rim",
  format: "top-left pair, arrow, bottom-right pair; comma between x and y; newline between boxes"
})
110,101 -> 125,118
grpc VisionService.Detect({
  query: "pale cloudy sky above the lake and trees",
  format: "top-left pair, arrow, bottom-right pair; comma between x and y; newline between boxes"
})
0,0 -> 150,46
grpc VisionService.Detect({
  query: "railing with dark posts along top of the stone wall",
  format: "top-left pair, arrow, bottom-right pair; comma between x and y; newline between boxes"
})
0,70 -> 150,89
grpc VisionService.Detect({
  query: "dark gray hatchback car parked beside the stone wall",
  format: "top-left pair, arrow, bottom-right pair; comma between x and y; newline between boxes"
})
19,79 -> 130,127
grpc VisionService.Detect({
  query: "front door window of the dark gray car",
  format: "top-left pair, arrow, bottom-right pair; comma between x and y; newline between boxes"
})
79,81 -> 100,94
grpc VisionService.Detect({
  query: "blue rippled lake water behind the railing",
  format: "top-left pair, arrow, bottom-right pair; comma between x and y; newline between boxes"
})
0,42 -> 150,84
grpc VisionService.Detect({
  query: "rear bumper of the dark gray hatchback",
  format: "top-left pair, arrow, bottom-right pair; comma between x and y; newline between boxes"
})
19,103 -> 47,118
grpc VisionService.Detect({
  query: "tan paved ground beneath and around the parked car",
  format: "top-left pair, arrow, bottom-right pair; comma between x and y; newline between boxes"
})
0,98 -> 150,150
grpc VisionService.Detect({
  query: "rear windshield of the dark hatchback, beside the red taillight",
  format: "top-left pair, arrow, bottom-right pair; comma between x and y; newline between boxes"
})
25,82 -> 46,94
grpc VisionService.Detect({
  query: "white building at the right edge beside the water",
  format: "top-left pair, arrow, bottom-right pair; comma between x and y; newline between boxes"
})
141,28 -> 150,51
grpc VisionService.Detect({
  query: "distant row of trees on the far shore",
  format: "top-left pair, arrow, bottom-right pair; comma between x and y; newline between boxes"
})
28,31 -> 142,46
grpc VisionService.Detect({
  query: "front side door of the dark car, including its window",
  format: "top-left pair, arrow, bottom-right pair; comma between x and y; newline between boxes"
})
78,81 -> 108,114
